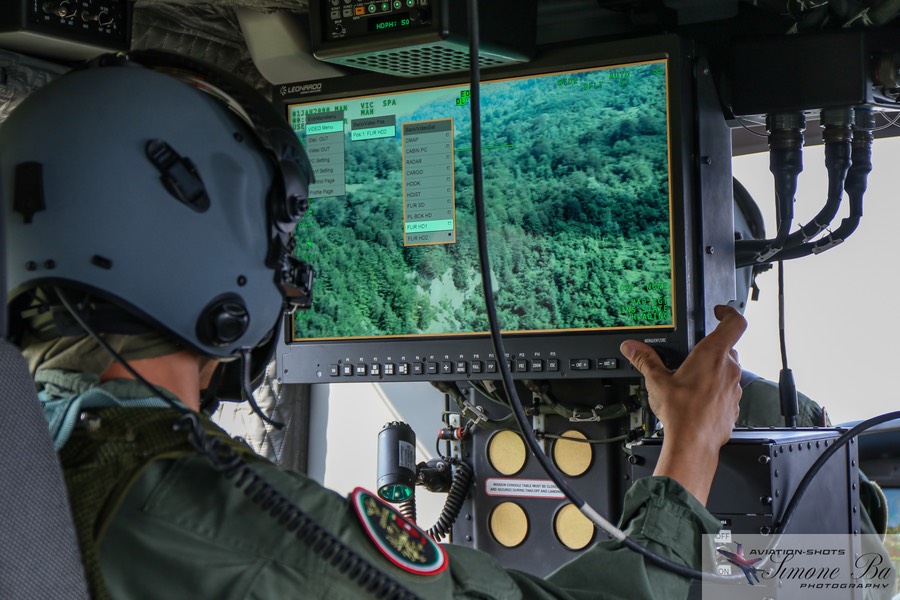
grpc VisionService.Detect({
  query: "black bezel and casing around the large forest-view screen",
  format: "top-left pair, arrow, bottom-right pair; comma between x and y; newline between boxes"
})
275,36 -> 734,383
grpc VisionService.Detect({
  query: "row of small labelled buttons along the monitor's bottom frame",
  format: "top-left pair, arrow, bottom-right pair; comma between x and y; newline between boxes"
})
328,358 -> 619,377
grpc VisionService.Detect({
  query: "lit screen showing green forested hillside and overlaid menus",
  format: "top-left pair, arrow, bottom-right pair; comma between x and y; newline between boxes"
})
288,60 -> 675,341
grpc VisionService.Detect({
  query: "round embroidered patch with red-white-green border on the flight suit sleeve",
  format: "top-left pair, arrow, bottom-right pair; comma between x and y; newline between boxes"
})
350,488 -> 448,575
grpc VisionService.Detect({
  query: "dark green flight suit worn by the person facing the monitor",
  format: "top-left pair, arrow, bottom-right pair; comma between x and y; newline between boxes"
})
49,374 -> 719,600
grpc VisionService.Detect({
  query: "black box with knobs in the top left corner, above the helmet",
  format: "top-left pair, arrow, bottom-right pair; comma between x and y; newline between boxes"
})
0,0 -> 132,60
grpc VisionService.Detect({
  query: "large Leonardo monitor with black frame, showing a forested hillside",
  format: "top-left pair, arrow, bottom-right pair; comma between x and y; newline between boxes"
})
279,38 -> 733,383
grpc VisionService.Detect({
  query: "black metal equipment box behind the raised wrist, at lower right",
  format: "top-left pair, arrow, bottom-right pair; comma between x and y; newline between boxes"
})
632,428 -> 860,534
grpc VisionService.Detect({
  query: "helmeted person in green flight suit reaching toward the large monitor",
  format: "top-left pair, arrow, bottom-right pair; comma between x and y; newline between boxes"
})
0,53 -> 746,600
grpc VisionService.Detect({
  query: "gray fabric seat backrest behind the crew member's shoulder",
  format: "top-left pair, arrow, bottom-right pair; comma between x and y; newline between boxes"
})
0,340 -> 89,600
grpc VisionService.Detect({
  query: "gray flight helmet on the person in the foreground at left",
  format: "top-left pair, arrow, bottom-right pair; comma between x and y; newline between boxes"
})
0,54 -> 312,359
